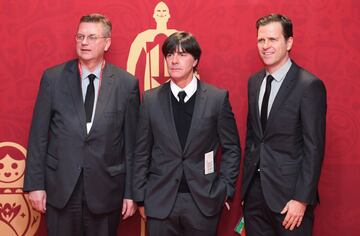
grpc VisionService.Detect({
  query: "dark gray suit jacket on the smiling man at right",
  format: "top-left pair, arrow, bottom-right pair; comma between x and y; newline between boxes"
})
241,62 -> 326,212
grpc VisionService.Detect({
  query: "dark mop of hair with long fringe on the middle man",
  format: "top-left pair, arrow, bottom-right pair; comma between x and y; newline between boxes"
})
162,32 -> 201,71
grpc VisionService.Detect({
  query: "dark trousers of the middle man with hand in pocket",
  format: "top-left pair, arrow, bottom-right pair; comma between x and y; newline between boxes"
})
147,193 -> 220,236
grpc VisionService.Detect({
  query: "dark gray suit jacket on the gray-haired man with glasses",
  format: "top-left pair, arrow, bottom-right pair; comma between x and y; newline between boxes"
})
24,60 -> 139,213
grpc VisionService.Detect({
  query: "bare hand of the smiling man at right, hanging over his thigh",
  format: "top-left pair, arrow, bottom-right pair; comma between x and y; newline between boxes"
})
281,200 -> 306,230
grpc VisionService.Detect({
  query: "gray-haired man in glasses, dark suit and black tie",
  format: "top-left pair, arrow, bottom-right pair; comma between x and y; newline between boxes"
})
24,14 -> 139,236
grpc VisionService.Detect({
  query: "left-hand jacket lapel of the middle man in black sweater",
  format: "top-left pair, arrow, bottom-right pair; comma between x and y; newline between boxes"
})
159,82 -> 182,152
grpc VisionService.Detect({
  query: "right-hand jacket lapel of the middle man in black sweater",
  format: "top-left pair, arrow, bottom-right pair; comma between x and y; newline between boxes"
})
184,80 -> 207,153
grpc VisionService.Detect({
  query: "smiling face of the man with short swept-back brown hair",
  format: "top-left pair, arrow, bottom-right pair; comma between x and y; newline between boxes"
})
257,22 -> 293,73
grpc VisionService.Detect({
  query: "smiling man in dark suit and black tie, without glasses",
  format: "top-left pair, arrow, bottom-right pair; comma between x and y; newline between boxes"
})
241,14 -> 326,236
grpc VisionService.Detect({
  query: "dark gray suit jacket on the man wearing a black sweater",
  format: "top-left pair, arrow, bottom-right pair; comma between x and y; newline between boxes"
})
133,82 -> 241,219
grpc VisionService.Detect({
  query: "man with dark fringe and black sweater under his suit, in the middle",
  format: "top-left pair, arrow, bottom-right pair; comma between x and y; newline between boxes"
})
133,32 -> 240,236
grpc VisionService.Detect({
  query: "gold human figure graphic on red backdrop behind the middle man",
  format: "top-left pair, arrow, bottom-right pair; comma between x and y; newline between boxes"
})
127,2 -> 177,90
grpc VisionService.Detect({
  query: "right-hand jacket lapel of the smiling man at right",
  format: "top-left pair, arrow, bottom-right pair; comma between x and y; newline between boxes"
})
267,62 -> 299,133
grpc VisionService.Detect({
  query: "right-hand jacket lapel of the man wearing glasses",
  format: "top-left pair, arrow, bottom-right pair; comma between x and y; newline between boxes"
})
89,64 -> 114,136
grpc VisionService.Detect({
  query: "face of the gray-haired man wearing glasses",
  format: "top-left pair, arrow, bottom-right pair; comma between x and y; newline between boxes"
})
76,22 -> 111,64
